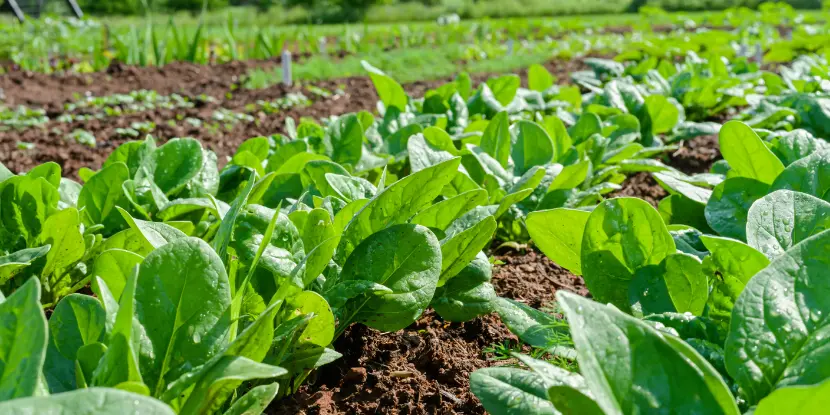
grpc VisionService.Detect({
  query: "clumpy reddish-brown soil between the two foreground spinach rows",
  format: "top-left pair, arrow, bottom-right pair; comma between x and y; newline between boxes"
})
268,251 -> 588,415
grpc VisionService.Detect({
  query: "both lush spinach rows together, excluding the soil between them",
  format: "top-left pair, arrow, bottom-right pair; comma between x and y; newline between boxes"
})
0,42 -> 830,414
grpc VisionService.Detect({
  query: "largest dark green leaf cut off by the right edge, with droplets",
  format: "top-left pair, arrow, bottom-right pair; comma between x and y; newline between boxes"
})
724,231 -> 830,404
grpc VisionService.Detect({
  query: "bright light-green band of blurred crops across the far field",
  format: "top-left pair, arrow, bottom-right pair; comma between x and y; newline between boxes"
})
0,4 -> 827,77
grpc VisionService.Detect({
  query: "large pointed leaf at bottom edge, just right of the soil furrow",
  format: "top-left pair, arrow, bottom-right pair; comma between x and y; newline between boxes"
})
556,291 -> 739,415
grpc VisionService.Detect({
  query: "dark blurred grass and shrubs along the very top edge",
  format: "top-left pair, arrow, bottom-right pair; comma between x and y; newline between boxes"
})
13,0 -> 827,24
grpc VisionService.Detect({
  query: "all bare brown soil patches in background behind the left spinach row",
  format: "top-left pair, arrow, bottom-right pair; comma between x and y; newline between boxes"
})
0,57 -> 584,178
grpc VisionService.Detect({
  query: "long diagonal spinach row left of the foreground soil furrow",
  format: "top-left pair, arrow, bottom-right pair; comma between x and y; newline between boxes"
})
0,51 -> 820,414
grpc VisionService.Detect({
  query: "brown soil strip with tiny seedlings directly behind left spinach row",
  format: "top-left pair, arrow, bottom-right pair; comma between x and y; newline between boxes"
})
0,78 -> 377,177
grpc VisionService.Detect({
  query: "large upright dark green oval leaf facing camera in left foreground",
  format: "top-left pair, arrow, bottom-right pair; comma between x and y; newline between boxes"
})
135,238 -> 231,396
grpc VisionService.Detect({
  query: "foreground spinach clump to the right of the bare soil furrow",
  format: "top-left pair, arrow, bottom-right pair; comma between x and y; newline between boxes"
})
471,117 -> 830,414
